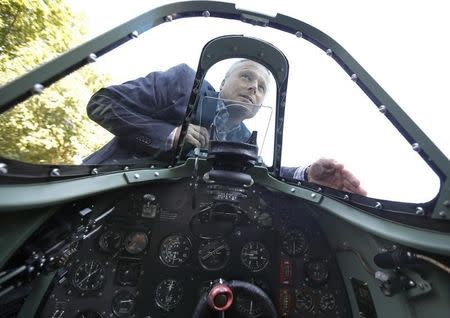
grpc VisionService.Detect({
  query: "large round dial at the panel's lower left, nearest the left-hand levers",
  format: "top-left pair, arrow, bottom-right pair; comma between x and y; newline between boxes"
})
72,260 -> 105,292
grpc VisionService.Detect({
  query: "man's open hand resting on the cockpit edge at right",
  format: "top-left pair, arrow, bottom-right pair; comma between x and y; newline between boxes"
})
307,158 -> 367,195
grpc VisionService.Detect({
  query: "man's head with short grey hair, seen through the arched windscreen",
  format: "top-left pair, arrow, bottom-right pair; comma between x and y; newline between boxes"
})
220,61 -> 270,119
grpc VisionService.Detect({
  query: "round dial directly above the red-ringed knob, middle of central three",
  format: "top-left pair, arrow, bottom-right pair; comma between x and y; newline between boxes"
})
198,240 -> 230,270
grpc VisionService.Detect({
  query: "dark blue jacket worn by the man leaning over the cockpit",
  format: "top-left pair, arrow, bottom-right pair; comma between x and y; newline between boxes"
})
84,64 -> 296,177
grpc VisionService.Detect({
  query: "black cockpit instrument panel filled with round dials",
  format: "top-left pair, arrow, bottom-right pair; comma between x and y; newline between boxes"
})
37,182 -> 351,318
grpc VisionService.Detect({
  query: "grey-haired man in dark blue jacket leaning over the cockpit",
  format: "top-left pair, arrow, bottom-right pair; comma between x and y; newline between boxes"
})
84,60 -> 367,195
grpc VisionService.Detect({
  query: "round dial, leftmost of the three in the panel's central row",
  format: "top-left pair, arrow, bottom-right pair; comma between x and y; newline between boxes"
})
159,235 -> 191,267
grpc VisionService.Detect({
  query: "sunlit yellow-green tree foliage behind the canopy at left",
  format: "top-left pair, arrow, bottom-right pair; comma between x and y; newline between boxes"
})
0,0 -> 110,164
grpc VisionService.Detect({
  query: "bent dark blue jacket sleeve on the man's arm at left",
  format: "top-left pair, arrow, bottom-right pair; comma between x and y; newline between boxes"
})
87,64 -> 195,153
